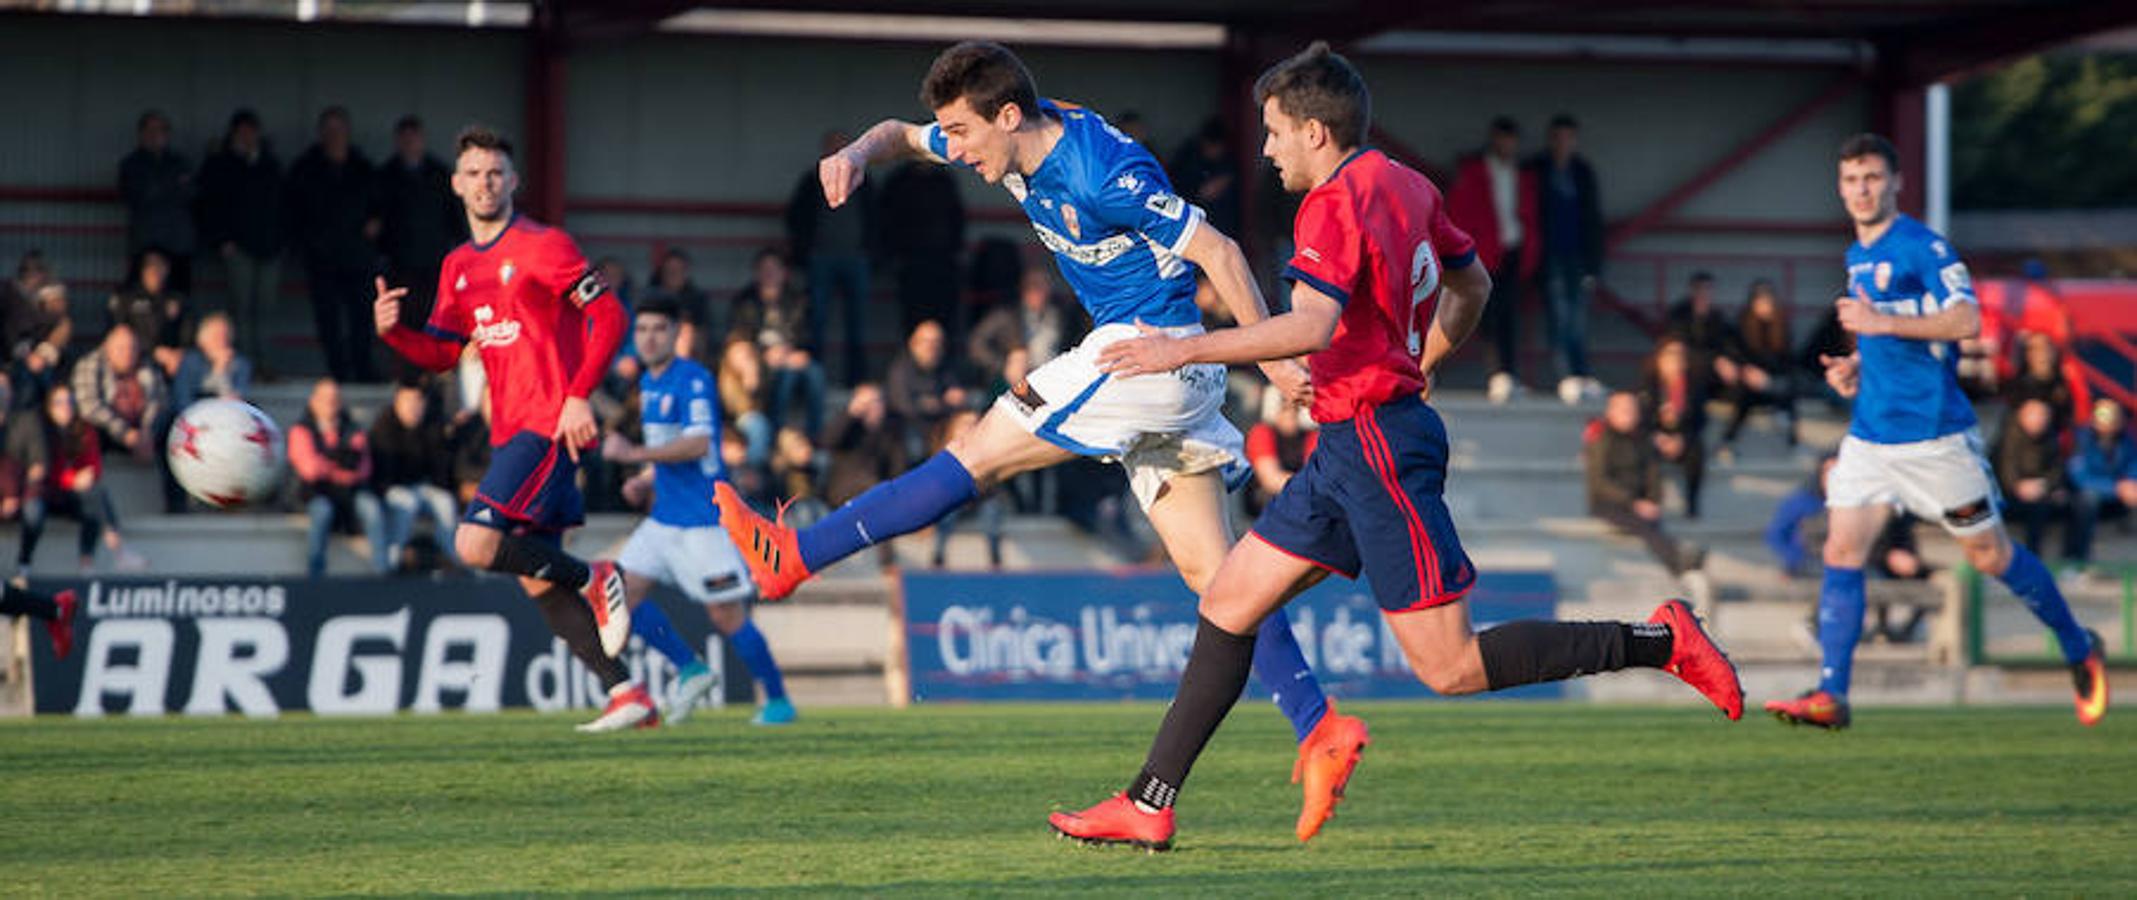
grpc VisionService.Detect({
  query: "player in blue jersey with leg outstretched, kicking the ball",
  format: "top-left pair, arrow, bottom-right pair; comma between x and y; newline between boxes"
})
718,41 -> 1368,840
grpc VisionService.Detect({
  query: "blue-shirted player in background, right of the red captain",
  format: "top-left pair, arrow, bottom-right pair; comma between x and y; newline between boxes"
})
603,299 -> 795,725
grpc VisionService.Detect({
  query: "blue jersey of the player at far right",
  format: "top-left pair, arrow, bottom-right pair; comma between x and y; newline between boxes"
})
1849,216 -> 1975,445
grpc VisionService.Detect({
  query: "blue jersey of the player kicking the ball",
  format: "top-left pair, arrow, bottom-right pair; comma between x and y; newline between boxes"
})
927,100 -> 1203,327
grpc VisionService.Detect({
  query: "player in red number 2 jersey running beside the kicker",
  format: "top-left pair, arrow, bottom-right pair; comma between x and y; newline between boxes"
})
1051,43 -> 1744,849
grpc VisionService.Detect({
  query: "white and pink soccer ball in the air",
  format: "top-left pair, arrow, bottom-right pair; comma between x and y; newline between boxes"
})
165,400 -> 282,507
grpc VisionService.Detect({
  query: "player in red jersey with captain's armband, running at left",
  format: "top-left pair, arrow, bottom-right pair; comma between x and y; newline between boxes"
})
374,126 -> 658,731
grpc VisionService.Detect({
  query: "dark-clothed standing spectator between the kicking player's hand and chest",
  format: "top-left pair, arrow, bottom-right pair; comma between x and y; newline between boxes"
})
880,162 -> 964,333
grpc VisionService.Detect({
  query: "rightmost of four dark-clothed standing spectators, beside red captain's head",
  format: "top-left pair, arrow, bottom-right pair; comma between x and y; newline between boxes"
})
365,115 -> 468,327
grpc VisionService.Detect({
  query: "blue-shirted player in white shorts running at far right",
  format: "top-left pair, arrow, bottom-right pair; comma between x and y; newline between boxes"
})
1765,135 -> 2107,729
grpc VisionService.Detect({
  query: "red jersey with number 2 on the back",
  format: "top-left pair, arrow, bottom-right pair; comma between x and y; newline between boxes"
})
1284,150 -> 1477,421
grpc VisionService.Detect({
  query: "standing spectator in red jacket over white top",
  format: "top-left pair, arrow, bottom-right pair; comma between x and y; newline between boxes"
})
1447,115 -> 1543,402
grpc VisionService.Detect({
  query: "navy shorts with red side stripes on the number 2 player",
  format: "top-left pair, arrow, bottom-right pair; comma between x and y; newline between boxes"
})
1254,398 -> 1477,611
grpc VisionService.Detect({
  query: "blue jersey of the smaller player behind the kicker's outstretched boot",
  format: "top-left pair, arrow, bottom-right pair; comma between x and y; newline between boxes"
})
639,357 -> 727,528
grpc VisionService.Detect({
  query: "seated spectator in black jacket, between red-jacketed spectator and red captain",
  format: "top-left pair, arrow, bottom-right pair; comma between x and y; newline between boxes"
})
370,381 -> 459,569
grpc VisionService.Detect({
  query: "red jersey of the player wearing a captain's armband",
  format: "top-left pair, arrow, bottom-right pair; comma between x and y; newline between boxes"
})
425,216 -> 607,447
